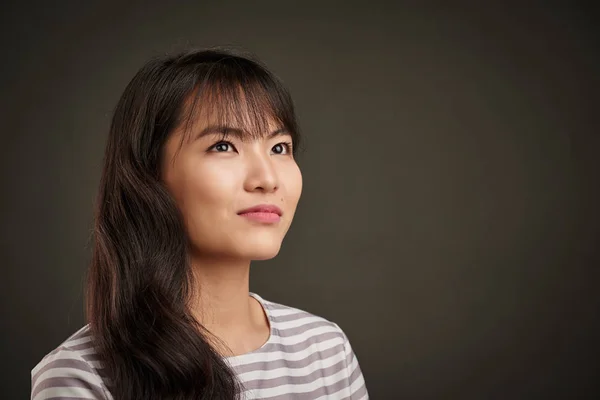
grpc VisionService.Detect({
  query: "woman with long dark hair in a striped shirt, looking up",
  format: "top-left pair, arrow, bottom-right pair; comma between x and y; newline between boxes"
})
31,50 -> 368,400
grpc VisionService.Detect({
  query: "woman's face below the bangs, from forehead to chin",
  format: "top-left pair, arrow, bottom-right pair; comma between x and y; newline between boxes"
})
162,110 -> 302,260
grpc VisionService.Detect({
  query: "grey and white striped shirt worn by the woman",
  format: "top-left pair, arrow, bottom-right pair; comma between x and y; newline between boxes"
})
31,292 -> 369,400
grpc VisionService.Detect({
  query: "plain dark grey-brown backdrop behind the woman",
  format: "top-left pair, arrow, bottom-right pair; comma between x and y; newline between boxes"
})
0,1 -> 600,399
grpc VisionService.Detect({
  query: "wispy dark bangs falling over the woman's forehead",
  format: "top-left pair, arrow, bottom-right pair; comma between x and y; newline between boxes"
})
180,57 -> 299,153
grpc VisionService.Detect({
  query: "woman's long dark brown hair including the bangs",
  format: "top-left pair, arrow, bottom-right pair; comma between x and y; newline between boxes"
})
86,49 -> 298,400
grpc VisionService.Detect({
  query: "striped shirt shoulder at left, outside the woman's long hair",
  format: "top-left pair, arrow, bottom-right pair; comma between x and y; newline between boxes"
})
31,325 -> 110,400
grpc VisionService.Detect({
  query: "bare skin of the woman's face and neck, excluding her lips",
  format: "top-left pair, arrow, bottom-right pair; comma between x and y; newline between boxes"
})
162,108 -> 302,355
